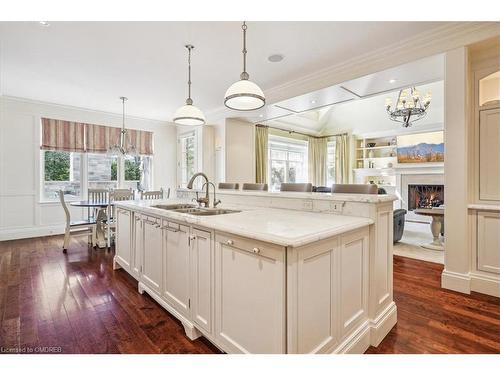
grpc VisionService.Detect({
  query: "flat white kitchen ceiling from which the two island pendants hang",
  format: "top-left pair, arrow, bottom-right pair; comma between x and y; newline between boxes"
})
0,22 -> 442,120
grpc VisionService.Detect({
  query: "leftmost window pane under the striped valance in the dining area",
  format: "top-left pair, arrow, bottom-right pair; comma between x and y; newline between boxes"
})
42,151 -> 82,200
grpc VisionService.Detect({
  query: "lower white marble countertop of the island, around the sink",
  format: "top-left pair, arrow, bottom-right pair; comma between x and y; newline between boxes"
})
115,199 -> 373,247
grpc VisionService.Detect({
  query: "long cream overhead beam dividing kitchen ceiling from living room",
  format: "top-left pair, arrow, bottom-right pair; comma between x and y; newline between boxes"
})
207,22 -> 500,122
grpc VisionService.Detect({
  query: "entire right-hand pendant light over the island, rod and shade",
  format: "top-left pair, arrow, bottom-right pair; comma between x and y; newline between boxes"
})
224,22 -> 266,111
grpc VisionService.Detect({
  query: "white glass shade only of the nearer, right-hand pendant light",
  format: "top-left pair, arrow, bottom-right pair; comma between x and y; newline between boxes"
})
224,79 -> 266,111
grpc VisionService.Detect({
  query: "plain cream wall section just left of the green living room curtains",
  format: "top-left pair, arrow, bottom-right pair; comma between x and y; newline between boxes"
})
225,118 -> 255,184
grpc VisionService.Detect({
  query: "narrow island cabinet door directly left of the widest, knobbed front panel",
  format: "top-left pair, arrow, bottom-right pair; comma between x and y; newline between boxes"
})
191,229 -> 210,333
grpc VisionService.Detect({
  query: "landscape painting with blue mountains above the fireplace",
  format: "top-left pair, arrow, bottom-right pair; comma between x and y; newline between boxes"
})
397,131 -> 444,163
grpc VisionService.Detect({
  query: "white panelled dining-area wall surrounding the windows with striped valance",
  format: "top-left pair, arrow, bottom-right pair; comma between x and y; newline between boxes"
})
0,97 -> 176,240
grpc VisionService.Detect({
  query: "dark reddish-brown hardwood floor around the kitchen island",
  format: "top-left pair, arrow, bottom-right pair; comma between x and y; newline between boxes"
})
0,236 -> 500,353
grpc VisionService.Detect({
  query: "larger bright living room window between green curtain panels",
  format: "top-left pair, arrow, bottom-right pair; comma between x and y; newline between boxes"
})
268,136 -> 307,190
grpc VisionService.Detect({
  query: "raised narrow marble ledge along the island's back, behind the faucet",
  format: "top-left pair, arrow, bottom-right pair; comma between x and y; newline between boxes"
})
177,188 -> 398,203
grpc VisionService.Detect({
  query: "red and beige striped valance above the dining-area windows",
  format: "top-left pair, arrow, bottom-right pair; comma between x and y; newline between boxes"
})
41,118 -> 153,155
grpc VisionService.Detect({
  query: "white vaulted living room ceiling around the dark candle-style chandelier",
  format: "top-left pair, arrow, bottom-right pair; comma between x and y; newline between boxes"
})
264,55 -> 444,135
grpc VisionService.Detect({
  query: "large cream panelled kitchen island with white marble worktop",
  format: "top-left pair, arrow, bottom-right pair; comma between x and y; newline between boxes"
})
114,196 -> 396,353
